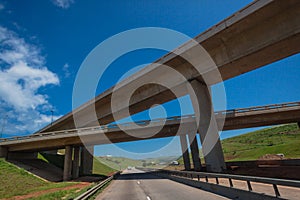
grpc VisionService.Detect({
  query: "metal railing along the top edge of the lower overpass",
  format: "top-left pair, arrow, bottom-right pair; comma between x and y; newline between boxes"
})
0,102 -> 300,144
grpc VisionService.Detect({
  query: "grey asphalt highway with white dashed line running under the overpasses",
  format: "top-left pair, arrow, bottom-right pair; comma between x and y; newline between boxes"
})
96,168 -> 228,200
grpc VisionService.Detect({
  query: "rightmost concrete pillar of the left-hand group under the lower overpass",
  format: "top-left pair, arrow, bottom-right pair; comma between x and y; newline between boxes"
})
80,146 -> 94,175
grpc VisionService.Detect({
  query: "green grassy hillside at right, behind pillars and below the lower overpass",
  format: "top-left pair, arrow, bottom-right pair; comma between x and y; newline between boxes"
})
178,124 -> 300,164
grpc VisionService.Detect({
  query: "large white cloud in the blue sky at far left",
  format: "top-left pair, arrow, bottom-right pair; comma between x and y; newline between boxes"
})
0,26 -> 59,133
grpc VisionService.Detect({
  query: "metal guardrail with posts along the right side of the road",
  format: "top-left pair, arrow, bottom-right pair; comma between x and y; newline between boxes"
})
153,170 -> 300,198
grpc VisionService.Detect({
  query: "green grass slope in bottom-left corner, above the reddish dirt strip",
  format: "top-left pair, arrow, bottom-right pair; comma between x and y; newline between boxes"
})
0,158 -> 74,198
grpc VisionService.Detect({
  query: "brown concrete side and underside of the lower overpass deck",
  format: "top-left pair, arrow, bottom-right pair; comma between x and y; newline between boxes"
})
2,105 -> 300,151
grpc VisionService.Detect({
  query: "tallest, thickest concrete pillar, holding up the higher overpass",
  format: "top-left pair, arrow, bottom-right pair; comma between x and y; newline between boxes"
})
188,80 -> 226,172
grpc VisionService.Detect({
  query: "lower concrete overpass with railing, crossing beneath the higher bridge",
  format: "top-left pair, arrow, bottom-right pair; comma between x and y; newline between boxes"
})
0,102 -> 300,180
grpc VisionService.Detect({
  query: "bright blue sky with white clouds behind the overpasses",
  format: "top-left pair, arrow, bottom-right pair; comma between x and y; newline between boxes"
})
0,0 -> 300,157
